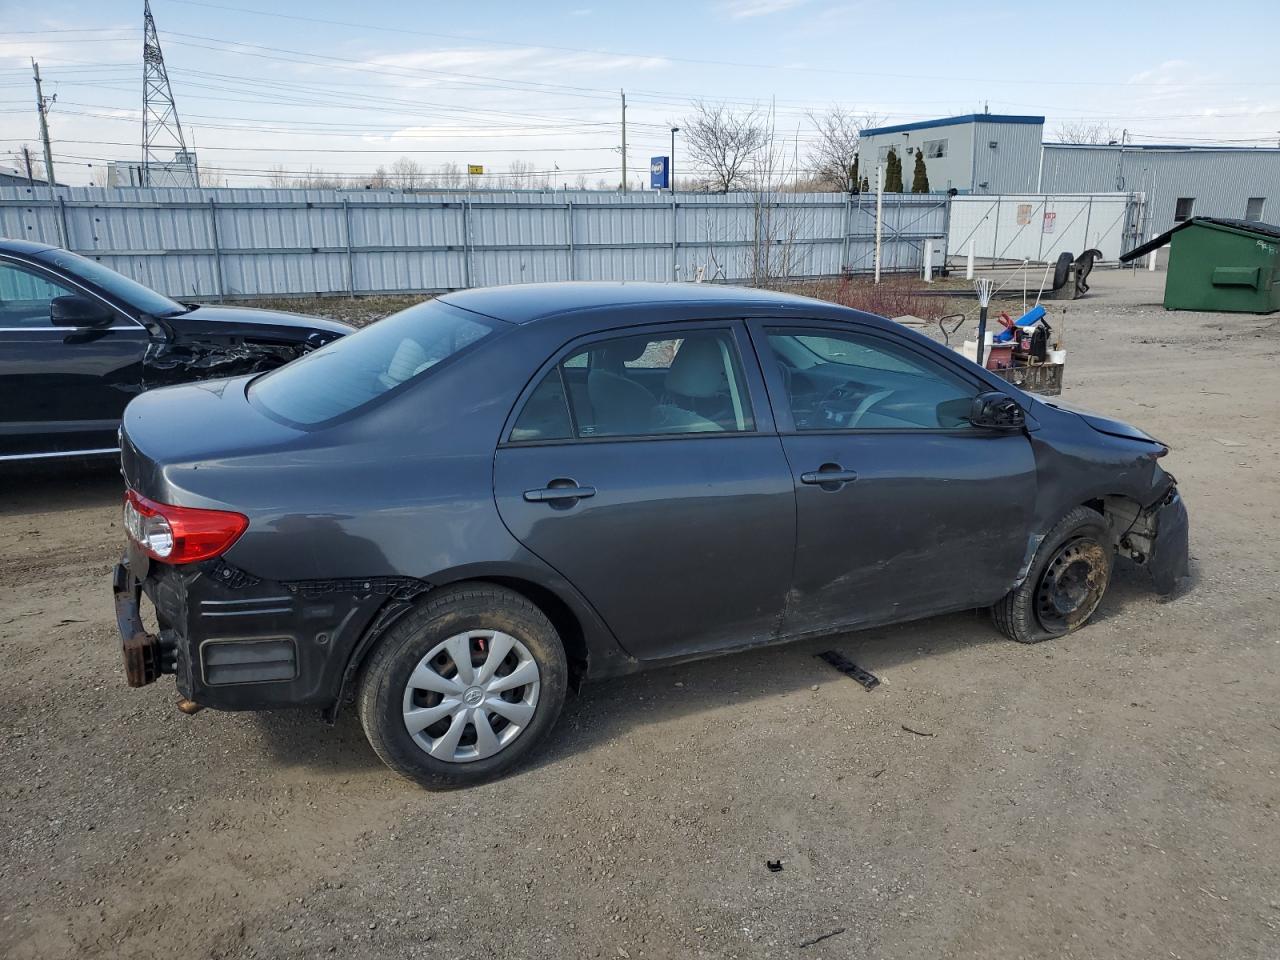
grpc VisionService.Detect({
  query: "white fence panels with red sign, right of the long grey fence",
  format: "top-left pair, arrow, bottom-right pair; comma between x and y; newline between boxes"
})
947,193 -> 1142,264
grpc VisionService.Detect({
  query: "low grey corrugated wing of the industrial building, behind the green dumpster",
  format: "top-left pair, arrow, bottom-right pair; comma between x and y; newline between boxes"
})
1041,143 -> 1280,238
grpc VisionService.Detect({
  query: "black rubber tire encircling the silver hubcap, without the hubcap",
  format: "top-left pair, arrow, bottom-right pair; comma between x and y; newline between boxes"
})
357,584 -> 568,790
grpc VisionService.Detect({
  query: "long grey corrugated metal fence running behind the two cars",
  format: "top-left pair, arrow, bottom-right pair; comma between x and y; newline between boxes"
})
0,187 -> 947,298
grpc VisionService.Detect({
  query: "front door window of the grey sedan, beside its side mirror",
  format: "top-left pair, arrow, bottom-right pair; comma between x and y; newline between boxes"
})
768,329 -> 977,430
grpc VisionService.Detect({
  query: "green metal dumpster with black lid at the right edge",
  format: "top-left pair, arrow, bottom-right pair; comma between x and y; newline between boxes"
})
1120,216 -> 1280,314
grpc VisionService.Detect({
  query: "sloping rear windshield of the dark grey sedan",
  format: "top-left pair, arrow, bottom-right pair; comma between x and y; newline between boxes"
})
248,300 -> 499,426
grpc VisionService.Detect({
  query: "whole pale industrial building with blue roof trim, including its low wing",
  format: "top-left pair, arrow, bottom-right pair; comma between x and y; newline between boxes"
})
860,114 -> 1280,233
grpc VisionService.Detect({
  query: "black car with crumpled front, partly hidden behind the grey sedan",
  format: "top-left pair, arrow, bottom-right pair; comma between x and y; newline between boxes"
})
0,239 -> 352,461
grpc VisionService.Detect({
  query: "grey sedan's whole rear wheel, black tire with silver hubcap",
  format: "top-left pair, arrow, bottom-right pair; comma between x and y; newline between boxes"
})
358,584 -> 568,790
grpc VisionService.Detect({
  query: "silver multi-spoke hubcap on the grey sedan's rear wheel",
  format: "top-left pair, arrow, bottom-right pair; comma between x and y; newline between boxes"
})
404,630 -> 540,763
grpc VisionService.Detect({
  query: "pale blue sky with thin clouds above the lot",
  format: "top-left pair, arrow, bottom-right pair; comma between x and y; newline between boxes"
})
0,0 -> 1280,187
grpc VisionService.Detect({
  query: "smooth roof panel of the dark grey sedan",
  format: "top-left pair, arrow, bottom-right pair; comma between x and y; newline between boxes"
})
440,282 -> 841,324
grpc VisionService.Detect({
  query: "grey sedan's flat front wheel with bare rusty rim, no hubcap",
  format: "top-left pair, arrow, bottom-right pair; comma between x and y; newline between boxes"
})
991,507 -> 1115,644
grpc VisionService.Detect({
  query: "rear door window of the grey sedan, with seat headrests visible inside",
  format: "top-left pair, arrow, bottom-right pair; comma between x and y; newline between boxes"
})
511,330 -> 755,442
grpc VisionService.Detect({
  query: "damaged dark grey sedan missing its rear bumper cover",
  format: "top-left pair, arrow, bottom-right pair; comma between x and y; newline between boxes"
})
114,283 -> 1188,786
